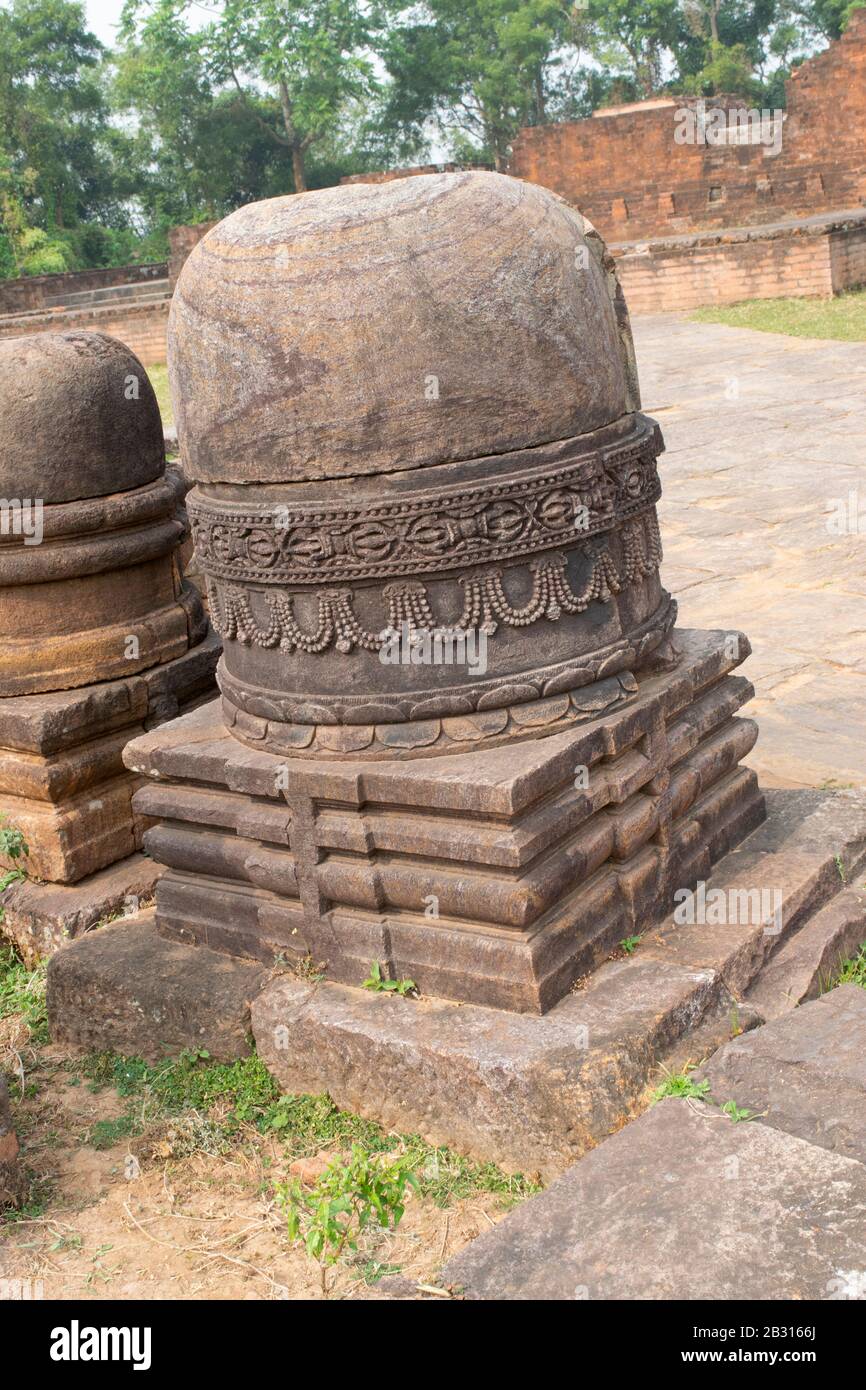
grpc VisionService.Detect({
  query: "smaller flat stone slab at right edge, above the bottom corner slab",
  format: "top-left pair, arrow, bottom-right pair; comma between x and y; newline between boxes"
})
701,984 -> 866,1163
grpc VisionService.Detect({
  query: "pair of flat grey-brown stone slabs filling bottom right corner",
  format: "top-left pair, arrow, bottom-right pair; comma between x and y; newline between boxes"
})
436,986 -> 866,1301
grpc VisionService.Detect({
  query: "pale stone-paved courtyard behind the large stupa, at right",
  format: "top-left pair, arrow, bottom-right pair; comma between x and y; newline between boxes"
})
634,314 -> 866,787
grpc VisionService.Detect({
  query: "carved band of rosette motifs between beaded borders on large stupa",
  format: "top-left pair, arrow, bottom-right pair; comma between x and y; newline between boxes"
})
186,421 -> 662,584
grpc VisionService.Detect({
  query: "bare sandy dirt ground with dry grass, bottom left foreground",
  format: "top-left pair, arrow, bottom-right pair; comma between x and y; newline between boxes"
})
0,1019 -> 506,1300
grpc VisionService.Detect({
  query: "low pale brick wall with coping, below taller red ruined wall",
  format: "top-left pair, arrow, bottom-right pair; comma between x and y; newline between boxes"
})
610,211 -> 866,314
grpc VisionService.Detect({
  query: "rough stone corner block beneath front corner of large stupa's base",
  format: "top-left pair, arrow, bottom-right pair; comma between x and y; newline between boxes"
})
253,960 -> 719,1176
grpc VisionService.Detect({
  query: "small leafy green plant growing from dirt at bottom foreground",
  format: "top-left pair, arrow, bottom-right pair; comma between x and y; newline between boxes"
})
274,1144 -> 418,1298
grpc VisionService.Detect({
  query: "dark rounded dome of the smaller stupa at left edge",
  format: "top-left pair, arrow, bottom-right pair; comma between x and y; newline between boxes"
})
0,332 -> 165,505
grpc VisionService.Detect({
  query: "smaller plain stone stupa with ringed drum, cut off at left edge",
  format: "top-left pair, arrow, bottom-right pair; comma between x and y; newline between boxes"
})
0,332 -> 218,954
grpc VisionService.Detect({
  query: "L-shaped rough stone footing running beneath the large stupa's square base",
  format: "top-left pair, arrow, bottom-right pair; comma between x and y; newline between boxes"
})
49,792 -> 866,1176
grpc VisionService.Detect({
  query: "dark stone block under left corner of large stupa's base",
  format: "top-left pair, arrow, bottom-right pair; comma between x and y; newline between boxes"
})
47,912 -> 268,1061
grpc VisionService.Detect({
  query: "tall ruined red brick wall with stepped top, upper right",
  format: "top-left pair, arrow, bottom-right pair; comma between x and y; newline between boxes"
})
509,8 -> 866,242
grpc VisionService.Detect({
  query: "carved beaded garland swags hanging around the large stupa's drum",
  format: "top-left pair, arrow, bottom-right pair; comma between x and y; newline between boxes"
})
207,510 -> 662,655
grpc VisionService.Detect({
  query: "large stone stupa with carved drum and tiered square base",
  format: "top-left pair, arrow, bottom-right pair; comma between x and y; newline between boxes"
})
126,174 -> 763,1012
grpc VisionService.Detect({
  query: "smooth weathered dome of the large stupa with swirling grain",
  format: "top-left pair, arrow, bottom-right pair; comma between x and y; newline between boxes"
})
168,172 -> 630,482
